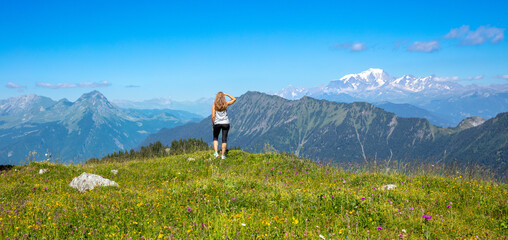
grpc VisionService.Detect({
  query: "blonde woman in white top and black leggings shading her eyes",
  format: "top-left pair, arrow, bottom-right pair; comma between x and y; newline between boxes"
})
212,92 -> 236,159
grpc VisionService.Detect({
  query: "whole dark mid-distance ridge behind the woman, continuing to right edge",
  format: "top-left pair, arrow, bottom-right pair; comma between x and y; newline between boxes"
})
142,92 -> 508,175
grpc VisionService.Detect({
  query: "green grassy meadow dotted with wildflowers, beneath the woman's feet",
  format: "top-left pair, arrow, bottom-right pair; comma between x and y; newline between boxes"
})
0,151 -> 508,239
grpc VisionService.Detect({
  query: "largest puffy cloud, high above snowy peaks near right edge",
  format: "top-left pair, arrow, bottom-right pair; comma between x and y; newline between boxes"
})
444,25 -> 505,45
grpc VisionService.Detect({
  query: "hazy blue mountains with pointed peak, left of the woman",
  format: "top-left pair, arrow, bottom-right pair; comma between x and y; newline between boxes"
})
0,91 -> 202,165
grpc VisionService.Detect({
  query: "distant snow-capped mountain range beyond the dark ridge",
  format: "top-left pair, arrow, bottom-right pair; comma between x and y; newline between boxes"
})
275,68 -> 508,127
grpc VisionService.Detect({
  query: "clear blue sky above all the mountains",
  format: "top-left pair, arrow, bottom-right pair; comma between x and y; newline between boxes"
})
0,0 -> 508,101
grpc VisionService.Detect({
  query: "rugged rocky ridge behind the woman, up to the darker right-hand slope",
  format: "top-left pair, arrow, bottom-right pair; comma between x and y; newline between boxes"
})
143,92 -> 449,160
